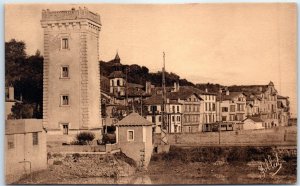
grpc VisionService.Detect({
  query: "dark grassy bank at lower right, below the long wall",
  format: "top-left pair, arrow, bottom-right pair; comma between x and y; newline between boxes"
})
148,146 -> 297,184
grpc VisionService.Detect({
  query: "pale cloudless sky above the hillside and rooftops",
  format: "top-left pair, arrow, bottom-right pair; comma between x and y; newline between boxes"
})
5,3 -> 297,115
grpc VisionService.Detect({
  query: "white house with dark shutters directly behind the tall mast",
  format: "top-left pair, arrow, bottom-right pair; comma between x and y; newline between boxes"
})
145,95 -> 182,133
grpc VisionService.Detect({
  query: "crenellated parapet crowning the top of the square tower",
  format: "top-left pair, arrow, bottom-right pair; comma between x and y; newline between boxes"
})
42,7 -> 101,25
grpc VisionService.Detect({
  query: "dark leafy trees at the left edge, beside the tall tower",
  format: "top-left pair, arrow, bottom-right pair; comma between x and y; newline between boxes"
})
5,39 -> 43,118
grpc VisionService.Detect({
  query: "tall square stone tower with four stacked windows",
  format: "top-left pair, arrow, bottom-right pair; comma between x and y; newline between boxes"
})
41,8 -> 102,141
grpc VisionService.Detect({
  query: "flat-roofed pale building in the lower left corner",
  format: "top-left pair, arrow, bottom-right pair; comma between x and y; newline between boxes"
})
4,119 -> 47,184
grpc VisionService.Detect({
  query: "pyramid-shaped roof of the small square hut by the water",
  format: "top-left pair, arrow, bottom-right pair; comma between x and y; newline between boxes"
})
115,112 -> 152,127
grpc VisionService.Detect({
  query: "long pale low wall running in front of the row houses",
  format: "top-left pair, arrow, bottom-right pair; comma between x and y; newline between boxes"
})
154,127 -> 297,145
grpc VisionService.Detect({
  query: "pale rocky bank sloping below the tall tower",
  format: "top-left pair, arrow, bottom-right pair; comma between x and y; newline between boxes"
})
14,153 -> 136,184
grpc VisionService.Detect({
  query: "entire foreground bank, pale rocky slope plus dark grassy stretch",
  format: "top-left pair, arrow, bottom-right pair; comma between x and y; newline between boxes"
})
16,146 -> 297,184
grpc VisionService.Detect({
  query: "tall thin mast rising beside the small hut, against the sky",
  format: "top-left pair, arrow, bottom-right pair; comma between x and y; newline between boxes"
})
161,52 -> 168,145
